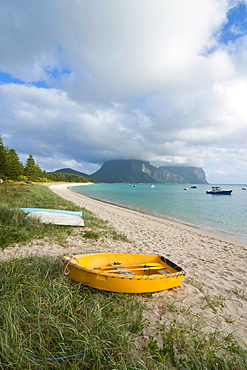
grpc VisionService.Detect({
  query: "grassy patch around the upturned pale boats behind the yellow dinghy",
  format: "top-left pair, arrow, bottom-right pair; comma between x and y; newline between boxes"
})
0,184 -> 127,249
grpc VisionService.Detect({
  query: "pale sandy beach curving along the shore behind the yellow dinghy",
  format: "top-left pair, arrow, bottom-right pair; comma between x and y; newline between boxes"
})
0,184 -> 247,344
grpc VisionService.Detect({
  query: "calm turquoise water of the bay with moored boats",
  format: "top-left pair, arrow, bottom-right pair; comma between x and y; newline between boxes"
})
73,184 -> 247,243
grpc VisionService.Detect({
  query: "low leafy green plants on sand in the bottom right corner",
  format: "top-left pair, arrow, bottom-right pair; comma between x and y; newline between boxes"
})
148,306 -> 247,370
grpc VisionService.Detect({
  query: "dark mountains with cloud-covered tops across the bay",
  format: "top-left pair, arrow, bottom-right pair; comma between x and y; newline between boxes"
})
55,159 -> 208,184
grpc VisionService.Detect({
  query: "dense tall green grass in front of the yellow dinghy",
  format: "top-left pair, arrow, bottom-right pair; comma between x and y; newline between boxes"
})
0,257 -> 151,369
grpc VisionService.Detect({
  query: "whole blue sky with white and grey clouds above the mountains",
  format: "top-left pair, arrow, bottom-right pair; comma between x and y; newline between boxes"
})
0,0 -> 247,184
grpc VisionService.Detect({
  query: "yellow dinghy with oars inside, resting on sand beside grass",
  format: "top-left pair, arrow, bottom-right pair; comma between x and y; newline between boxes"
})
63,253 -> 185,293
